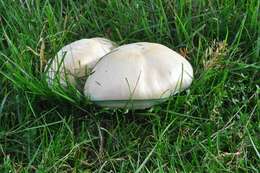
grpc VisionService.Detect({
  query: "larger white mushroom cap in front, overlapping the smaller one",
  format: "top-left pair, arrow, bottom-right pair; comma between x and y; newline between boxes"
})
84,42 -> 193,109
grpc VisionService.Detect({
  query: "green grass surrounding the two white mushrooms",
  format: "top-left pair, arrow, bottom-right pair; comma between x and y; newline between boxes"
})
0,0 -> 260,173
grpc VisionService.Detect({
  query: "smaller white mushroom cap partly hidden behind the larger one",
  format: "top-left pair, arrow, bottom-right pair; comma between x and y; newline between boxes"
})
46,37 -> 116,86
